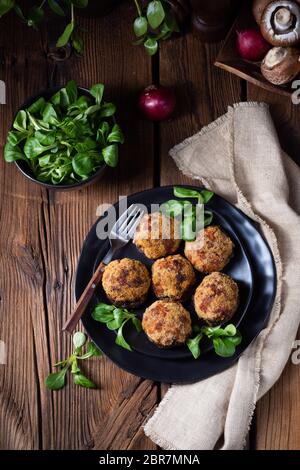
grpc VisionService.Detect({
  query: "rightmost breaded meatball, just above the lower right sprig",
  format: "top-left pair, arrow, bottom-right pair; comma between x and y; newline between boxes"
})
194,272 -> 239,325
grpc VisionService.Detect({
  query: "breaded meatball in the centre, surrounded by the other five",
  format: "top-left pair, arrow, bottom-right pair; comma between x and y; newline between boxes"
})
152,255 -> 196,300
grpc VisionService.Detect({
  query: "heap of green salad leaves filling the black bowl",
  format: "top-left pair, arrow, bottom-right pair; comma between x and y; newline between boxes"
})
4,80 -> 124,184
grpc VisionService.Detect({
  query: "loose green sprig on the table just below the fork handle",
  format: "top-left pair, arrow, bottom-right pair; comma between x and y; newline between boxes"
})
45,331 -> 102,390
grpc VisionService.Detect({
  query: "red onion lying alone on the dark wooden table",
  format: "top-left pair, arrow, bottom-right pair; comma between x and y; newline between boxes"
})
139,85 -> 176,121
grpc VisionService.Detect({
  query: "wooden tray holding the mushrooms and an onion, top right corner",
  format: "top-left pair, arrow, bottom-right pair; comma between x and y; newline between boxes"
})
215,2 -> 295,97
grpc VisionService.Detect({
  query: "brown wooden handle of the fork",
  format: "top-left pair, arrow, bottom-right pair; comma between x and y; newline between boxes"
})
63,262 -> 106,334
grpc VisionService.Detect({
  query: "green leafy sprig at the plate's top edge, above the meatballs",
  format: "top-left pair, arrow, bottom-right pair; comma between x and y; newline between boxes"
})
160,186 -> 214,241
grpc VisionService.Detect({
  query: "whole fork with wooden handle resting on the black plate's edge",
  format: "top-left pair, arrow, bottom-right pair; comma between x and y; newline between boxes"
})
63,204 -> 144,333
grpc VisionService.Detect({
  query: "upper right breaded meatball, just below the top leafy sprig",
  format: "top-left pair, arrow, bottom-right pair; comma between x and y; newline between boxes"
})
184,225 -> 234,273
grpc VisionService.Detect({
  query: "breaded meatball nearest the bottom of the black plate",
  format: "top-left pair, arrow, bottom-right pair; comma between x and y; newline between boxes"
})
142,300 -> 192,348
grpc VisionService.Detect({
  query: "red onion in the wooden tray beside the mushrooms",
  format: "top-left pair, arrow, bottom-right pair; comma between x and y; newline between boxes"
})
236,28 -> 271,62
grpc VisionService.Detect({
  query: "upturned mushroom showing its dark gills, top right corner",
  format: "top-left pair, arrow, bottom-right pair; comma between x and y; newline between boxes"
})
260,0 -> 300,46
